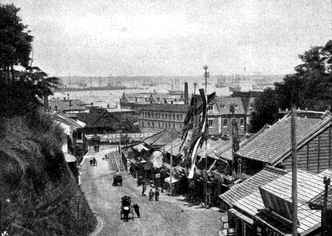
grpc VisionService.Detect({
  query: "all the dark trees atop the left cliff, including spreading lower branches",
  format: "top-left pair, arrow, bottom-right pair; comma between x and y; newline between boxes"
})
0,4 -> 59,117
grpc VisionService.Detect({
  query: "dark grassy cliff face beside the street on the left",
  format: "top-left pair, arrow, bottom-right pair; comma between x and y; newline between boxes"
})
0,113 -> 96,235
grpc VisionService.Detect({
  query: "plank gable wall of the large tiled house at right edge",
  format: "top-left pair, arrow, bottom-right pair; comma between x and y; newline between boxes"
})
282,126 -> 332,173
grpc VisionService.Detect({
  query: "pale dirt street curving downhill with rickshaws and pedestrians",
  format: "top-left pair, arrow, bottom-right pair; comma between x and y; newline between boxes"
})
81,150 -> 222,236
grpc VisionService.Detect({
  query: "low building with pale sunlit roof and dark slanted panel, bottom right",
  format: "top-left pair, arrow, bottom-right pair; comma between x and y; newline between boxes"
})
228,170 -> 330,236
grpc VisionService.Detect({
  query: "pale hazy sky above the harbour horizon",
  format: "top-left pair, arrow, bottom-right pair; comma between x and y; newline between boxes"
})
0,0 -> 332,75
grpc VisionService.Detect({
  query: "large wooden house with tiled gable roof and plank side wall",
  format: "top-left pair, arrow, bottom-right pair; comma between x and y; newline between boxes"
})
235,112 -> 332,175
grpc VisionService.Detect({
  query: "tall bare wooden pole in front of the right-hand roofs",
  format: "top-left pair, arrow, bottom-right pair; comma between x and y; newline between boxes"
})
291,106 -> 298,236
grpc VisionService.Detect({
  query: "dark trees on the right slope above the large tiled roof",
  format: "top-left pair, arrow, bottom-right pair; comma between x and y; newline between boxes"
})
250,40 -> 332,132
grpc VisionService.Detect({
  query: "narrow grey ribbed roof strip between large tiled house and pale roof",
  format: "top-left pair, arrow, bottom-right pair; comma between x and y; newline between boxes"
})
219,167 -> 286,207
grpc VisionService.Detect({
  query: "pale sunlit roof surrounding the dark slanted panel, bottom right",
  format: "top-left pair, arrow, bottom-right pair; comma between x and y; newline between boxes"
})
234,170 -> 324,234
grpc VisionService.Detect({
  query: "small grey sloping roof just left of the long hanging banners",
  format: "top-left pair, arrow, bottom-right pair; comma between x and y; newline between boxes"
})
143,128 -> 181,146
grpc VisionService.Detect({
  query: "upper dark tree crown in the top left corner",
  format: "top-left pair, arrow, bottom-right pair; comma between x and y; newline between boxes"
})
0,4 -> 33,81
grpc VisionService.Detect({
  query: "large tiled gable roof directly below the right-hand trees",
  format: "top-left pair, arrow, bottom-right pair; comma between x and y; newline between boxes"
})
237,115 -> 331,164
